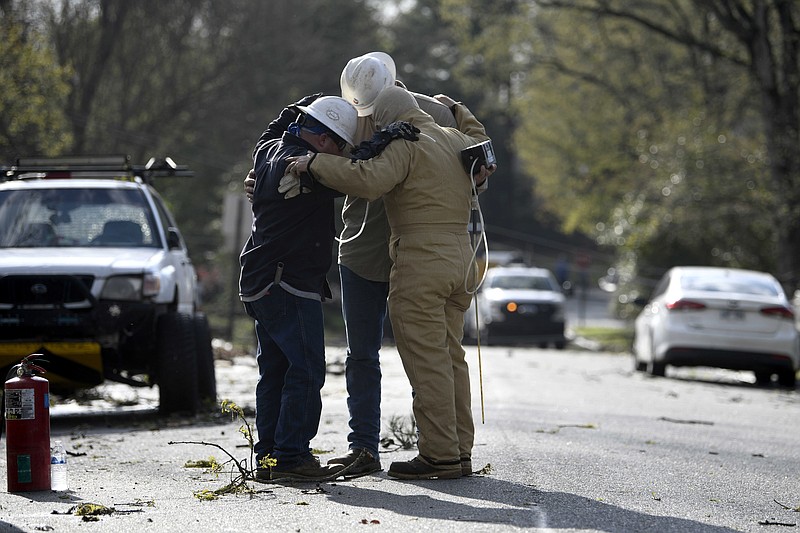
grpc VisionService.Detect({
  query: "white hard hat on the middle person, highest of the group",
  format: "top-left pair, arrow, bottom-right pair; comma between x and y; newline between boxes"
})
339,52 -> 397,117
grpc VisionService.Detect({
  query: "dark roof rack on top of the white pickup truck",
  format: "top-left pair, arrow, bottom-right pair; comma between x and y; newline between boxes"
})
0,155 -> 194,184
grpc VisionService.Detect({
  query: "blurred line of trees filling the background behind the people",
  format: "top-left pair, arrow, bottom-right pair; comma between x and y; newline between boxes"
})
0,0 -> 800,328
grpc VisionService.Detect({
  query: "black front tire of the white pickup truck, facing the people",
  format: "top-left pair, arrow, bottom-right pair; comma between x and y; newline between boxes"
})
156,312 -> 199,414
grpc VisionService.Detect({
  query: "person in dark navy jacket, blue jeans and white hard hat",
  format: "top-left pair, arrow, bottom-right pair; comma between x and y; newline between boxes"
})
239,95 -> 357,481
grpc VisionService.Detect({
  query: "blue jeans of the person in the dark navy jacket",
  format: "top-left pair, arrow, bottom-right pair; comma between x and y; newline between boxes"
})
244,287 -> 325,468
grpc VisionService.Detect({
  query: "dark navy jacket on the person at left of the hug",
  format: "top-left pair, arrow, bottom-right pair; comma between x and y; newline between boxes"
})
239,123 -> 342,301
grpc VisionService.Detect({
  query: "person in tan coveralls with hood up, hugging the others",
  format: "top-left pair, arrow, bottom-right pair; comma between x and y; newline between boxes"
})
289,87 -> 489,479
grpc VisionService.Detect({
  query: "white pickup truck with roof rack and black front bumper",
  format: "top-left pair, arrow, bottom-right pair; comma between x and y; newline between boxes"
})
0,156 -> 216,413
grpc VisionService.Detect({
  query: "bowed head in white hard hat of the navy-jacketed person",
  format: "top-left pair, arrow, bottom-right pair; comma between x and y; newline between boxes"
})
296,96 -> 358,155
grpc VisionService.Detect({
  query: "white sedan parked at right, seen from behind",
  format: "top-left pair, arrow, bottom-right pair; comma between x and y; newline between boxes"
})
633,267 -> 800,388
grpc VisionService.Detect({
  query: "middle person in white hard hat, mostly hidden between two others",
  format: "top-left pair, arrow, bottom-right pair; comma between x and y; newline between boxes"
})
328,52 -> 491,477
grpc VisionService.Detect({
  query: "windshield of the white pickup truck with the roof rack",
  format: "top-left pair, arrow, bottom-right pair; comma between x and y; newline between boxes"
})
0,189 -> 161,248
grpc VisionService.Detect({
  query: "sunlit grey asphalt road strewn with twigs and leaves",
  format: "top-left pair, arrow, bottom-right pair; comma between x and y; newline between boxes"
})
0,347 -> 800,533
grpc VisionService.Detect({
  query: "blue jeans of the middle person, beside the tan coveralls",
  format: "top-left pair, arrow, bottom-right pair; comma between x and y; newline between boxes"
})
339,265 -> 389,458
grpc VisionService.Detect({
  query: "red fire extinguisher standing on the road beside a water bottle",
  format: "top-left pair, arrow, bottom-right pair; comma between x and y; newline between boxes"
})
4,353 -> 50,492
